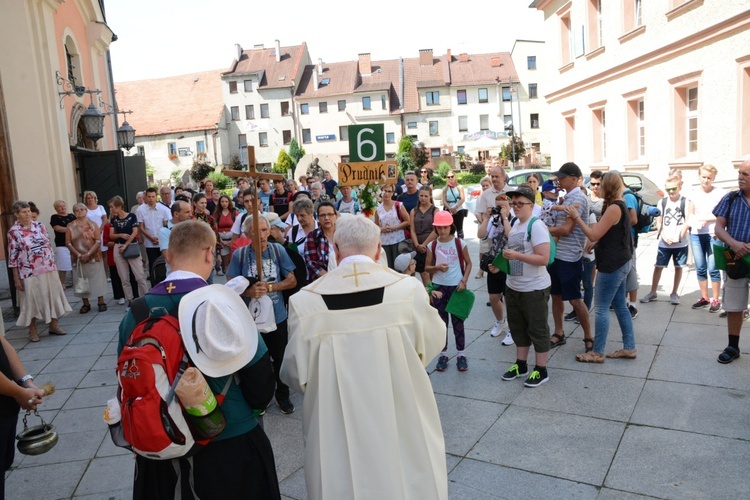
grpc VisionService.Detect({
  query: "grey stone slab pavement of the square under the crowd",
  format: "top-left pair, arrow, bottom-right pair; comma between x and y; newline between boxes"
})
0,221 -> 750,499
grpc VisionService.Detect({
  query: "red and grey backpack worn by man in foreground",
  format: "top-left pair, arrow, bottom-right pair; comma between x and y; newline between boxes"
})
115,297 -> 233,460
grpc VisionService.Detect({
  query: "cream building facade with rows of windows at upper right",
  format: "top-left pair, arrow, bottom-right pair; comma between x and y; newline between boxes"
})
531,0 -> 750,185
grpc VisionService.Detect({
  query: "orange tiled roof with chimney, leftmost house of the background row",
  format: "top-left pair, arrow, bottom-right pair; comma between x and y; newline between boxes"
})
229,42 -> 307,89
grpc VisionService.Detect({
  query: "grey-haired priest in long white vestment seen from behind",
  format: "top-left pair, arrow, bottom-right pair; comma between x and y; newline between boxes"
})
281,217 -> 448,500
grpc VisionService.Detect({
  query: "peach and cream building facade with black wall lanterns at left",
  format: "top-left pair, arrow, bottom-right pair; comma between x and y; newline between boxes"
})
0,0 -> 117,258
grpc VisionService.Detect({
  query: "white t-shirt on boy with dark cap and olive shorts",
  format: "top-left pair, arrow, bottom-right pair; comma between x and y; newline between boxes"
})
506,218 -> 552,292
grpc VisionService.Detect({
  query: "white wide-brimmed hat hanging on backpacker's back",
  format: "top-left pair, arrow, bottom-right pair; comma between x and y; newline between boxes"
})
179,285 -> 258,377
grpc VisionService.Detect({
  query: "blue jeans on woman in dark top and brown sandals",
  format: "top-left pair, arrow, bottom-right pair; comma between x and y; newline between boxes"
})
594,260 -> 635,354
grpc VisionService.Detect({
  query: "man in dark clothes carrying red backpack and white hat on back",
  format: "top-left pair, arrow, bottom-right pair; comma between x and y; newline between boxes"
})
118,220 -> 280,500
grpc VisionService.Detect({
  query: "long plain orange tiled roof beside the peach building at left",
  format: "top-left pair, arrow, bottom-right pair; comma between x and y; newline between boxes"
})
115,70 -> 224,137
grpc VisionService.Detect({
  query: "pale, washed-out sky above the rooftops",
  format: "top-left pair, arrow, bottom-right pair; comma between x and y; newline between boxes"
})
105,0 -> 544,82
